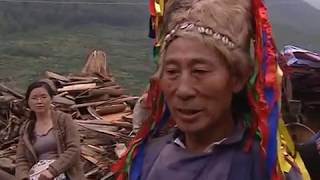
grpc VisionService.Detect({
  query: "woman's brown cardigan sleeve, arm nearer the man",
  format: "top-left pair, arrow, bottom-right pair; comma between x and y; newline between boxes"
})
48,115 -> 80,177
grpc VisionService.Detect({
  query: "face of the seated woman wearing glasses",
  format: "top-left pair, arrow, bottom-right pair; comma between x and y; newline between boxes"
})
28,87 -> 51,113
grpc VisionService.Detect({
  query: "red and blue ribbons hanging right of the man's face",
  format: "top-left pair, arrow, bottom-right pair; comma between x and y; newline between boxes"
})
249,0 -> 280,179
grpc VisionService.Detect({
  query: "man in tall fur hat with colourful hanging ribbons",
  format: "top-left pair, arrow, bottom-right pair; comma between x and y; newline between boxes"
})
113,0 -> 310,180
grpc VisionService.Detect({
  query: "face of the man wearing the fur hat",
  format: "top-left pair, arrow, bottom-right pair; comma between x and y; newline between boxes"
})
160,38 -> 242,133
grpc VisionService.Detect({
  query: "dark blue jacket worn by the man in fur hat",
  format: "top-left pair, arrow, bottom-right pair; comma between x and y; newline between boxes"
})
140,130 -> 269,180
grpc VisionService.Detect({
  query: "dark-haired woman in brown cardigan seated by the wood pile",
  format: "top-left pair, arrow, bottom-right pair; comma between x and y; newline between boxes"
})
16,82 -> 85,180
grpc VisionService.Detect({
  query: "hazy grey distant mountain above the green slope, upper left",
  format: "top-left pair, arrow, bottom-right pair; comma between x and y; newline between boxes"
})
0,0 -> 148,33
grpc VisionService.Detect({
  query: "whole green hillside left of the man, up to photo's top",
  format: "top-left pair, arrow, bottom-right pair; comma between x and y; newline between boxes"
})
0,1 -> 154,94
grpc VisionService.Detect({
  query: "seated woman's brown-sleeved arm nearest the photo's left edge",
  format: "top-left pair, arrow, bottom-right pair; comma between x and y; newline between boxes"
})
16,133 -> 31,180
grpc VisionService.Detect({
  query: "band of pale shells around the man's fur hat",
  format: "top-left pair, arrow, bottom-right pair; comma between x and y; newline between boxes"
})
164,22 -> 236,49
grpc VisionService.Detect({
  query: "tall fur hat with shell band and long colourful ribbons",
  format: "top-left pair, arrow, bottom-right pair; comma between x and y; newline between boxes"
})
113,0 -> 280,180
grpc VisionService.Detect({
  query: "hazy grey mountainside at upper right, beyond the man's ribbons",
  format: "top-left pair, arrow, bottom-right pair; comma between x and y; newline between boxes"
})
266,0 -> 320,51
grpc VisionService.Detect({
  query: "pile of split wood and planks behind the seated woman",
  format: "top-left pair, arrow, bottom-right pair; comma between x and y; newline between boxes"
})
0,51 -> 138,179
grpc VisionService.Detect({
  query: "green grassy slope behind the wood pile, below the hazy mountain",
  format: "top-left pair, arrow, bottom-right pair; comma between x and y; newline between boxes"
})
0,25 -> 154,94
